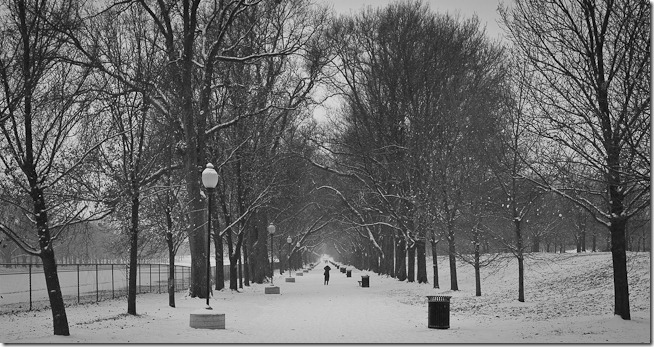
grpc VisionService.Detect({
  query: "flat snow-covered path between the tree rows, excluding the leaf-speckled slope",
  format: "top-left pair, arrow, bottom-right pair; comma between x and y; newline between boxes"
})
0,256 -> 651,343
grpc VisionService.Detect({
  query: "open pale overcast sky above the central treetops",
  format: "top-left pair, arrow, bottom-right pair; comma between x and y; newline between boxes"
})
318,0 -> 508,39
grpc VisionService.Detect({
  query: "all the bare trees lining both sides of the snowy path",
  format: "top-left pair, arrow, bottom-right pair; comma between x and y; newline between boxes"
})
0,0 -> 650,335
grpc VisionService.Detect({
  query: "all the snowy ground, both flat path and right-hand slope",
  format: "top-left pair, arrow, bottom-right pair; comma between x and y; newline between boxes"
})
0,253 -> 652,344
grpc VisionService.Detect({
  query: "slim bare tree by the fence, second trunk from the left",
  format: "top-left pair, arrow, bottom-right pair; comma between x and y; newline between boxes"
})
90,2 -> 179,315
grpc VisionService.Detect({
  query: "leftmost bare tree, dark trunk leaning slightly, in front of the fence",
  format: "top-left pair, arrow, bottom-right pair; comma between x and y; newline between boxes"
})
0,0 -> 111,335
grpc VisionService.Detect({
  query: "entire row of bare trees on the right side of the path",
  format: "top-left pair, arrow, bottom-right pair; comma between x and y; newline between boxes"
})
308,0 -> 651,319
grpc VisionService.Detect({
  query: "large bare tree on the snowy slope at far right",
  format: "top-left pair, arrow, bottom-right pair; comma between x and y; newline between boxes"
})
501,0 -> 651,319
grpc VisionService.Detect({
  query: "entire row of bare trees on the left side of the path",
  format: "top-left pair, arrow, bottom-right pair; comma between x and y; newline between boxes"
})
0,0 -> 336,335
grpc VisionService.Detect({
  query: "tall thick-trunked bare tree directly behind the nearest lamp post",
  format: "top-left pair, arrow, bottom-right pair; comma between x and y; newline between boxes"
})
59,0 -> 326,297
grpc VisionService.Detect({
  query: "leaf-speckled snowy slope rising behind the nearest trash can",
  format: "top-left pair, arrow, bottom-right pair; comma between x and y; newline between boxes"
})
394,252 -> 651,320
